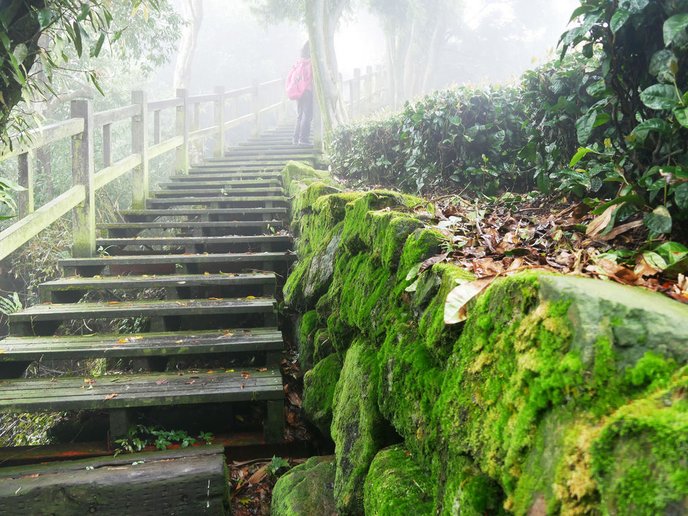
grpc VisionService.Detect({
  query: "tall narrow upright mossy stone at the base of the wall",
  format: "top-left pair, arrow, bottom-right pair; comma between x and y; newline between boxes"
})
331,340 -> 388,514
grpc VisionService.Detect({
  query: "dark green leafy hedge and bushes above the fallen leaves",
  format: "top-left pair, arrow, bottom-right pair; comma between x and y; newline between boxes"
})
330,0 -> 688,236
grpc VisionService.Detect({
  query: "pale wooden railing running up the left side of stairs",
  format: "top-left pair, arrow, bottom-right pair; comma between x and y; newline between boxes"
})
0,68 -> 384,260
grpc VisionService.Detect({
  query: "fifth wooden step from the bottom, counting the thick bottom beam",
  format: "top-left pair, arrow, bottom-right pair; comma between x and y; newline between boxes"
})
39,273 -> 276,302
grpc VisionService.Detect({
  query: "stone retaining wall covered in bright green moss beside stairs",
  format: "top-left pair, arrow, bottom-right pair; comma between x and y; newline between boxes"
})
274,160 -> 688,515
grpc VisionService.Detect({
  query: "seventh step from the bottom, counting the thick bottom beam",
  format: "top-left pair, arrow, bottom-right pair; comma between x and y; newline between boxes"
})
96,235 -> 292,255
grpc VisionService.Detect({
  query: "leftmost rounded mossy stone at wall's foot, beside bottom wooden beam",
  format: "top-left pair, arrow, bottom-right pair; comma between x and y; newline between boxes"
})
270,457 -> 336,516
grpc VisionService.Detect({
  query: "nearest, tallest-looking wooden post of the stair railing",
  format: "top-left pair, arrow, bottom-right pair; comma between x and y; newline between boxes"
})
71,99 -> 96,258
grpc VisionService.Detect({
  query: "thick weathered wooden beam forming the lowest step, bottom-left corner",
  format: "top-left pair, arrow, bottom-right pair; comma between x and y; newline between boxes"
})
0,446 -> 229,516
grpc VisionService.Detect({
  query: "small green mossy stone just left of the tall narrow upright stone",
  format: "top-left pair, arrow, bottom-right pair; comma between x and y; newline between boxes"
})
303,355 -> 342,437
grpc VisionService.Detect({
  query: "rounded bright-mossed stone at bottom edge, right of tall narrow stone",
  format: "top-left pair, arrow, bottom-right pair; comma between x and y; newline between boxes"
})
364,446 -> 433,516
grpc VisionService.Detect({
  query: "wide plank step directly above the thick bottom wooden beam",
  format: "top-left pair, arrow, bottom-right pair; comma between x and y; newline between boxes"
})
0,369 -> 284,412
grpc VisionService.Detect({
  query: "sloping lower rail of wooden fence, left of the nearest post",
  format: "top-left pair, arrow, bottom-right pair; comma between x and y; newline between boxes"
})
0,185 -> 86,260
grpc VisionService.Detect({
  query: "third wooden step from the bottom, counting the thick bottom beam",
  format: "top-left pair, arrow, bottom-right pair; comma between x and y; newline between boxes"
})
0,328 -> 284,364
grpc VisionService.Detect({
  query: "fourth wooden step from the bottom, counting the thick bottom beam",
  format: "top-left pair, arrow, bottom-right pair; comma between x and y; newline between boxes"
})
8,296 -> 275,325
